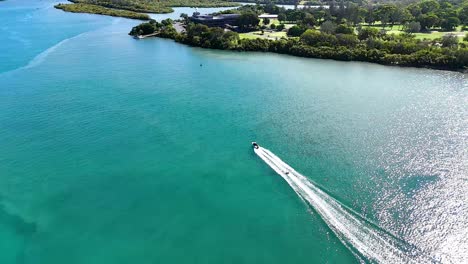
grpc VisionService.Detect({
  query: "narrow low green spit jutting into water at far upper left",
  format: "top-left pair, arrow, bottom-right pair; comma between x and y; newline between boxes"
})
55,4 -> 150,20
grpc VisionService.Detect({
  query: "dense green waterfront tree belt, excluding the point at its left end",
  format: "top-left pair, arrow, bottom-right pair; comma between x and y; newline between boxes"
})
177,25 -> 468,69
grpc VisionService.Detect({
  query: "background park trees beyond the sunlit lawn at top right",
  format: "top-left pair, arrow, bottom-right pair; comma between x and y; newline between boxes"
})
265,0 -> 468,31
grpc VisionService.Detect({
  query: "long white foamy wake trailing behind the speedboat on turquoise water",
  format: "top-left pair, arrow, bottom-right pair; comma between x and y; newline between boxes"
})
254,147 -> 436,263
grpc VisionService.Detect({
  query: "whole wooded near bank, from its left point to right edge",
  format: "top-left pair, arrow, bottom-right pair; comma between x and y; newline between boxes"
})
129,21 -> 468,72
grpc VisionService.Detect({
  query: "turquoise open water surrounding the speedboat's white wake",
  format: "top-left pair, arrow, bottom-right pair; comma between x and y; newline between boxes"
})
0,0 -> 468,263
